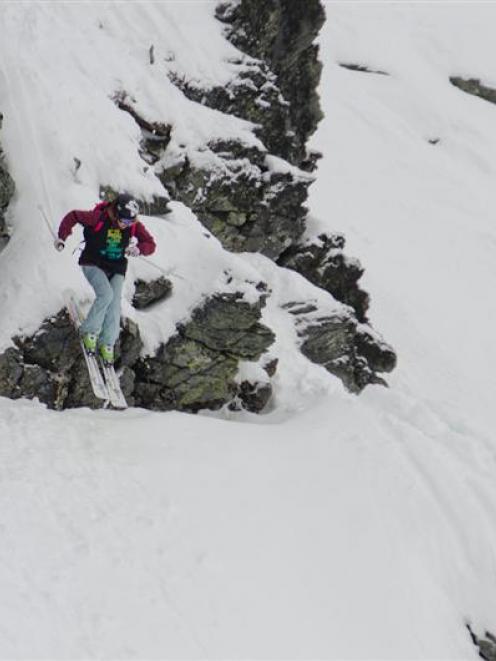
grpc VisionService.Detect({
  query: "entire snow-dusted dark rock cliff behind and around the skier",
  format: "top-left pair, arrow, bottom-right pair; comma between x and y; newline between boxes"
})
0,0 -> 396,411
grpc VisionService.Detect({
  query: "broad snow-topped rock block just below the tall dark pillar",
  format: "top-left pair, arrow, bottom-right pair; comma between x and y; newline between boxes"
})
159,141 -> 312,259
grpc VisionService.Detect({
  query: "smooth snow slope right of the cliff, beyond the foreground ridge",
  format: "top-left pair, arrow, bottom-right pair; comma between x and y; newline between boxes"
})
312,3 -> 496,444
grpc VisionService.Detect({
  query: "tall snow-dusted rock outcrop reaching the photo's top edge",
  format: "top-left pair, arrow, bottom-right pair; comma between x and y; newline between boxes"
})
151,0 -> 324,259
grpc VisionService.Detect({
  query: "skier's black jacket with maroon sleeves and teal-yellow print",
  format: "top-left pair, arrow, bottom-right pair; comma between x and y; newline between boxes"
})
58,202 -> 156,273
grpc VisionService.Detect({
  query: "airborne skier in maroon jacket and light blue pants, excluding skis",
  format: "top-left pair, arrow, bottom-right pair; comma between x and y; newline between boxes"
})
54,193 -> 155,365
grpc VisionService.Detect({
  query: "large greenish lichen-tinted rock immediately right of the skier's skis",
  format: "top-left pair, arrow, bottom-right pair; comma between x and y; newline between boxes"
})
135,294 -> 274,411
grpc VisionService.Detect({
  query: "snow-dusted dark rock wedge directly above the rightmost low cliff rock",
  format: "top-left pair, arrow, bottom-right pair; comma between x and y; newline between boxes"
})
278,234 -> 369,322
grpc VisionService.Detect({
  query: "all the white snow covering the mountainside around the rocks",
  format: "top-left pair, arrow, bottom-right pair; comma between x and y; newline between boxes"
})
0,2 -> 496,659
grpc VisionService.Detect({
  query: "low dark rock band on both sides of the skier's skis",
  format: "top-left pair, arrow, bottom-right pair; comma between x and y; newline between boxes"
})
0,287 -> 274,412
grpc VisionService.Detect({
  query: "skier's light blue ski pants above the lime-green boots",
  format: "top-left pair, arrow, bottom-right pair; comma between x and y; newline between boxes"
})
80,266 -> 124,346
